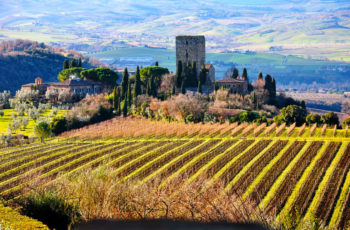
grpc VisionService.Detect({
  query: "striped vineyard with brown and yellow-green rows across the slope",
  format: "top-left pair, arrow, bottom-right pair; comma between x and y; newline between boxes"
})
0,118 -> 350,228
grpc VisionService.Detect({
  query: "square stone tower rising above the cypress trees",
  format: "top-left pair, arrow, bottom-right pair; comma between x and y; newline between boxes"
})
176,36 -> 205,77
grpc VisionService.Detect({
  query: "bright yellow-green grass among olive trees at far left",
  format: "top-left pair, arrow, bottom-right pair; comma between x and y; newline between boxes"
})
0,109 -> 65,136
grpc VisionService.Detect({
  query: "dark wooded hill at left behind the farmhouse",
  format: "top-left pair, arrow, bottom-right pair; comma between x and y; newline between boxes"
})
0,40 -> 101,93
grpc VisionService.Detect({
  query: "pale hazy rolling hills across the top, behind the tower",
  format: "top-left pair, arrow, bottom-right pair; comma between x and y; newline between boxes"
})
0,0 -> 350,62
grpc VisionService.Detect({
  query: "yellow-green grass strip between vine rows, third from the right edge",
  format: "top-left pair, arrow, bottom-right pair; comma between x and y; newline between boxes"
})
276,141 -> 330,222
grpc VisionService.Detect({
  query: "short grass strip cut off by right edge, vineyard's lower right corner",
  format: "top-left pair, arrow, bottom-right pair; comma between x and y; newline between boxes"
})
329,160 -> 350,228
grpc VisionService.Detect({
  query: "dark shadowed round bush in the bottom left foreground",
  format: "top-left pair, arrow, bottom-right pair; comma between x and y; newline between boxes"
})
20,191 -> 80,229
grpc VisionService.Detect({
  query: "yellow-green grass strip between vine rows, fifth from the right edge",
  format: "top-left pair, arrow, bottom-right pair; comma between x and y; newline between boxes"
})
242,141 -> 295,200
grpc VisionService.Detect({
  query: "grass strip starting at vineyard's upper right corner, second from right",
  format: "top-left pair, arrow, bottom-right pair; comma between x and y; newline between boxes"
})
304,142 -> 349,219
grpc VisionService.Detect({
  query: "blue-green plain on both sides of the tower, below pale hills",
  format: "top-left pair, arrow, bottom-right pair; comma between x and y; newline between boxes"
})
88,47 -> 349,87
